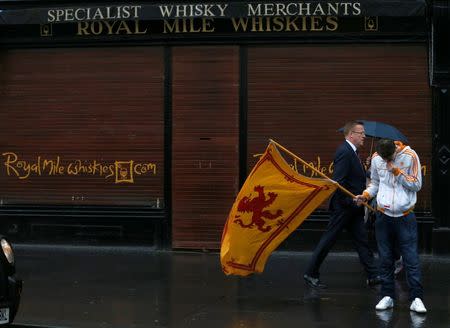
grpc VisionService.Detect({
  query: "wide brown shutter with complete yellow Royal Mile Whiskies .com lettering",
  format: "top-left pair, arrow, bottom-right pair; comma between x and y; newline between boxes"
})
0,47 -> 164,207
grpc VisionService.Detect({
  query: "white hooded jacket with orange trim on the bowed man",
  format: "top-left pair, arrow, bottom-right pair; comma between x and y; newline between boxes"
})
363,146 -> 422,217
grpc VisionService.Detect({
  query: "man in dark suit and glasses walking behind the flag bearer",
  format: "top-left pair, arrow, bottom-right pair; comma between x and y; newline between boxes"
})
303,121 -> 381,288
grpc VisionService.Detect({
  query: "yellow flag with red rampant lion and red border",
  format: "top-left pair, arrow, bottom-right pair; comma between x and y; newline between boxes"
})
220,143 -> 336,276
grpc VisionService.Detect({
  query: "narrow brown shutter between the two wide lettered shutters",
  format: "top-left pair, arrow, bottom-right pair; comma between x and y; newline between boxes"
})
172,47 -> 239,248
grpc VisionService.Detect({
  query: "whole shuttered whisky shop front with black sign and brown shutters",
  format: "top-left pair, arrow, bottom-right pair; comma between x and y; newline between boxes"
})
0,0 -> 450,252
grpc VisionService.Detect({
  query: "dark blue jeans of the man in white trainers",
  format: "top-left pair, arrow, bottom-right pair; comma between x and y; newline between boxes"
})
375,212 -> 423,300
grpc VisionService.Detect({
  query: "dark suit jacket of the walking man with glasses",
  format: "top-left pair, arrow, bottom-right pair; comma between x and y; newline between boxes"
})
330,141 -> 366,210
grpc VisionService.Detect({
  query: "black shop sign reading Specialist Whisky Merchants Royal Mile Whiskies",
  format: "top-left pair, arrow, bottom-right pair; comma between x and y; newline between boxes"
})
0,0 -> 425,42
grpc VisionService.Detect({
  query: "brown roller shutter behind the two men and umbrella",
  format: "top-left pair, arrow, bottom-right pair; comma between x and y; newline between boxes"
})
248,44 -> 432,211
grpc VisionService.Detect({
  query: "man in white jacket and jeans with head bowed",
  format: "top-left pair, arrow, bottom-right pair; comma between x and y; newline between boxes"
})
356,139 -> 427,313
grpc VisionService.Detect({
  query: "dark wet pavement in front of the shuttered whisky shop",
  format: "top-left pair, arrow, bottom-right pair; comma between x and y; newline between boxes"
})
8,244 -> 450,328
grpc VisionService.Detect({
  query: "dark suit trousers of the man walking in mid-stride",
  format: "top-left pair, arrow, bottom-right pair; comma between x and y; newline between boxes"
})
305,206 -> 378,279
